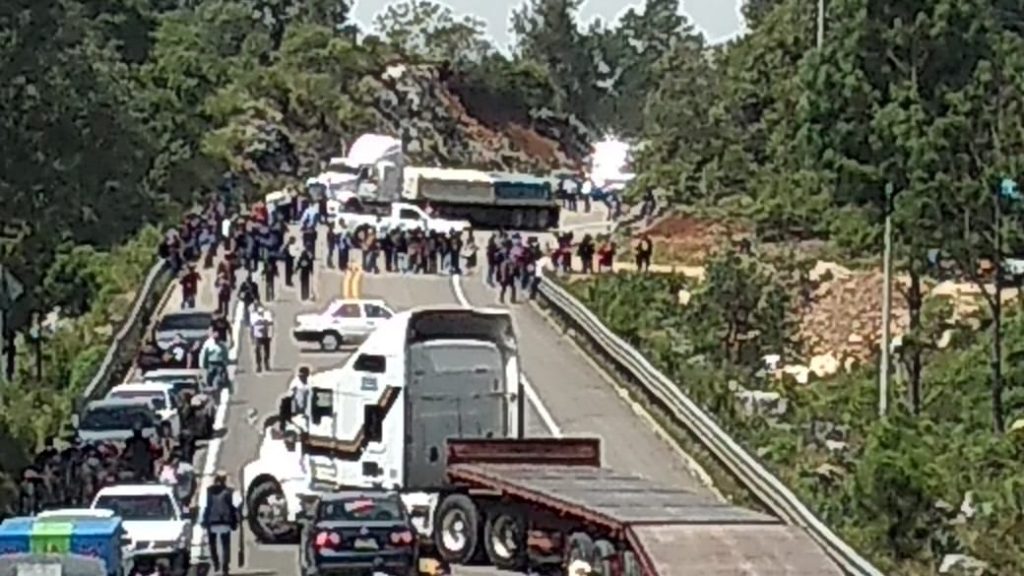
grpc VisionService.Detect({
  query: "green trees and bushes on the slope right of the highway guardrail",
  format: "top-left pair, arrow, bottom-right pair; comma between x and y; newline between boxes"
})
568,0 -> 1024,575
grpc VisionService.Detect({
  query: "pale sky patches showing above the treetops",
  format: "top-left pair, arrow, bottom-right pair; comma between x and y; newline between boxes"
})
353,0 -> 742,48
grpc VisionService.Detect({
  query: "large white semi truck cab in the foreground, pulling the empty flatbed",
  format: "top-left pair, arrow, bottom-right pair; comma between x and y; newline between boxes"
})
242,306 -> 525,542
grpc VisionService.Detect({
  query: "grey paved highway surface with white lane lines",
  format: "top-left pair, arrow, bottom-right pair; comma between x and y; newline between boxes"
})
192,206 -> 705,576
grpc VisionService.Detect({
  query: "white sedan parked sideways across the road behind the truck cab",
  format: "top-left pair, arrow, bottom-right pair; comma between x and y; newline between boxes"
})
292,298 -> 394,351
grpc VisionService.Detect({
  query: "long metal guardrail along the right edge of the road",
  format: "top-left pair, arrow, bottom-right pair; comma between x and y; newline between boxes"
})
539,270 -> 884,576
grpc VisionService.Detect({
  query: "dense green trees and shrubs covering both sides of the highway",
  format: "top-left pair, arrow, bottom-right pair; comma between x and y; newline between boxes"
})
0,0 -> 1024,574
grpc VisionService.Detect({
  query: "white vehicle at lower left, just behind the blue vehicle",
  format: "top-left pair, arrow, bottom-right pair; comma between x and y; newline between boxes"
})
91,484 -> 193,574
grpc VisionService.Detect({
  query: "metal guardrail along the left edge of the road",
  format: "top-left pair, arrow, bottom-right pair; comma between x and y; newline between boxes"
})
79,260 -> 171,406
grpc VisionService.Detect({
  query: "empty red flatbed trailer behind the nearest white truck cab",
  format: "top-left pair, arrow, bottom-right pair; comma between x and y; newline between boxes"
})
435,439 -> 843,576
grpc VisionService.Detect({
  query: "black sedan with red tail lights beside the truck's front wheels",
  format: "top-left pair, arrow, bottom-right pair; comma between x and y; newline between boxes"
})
299,491 -> 419,576
